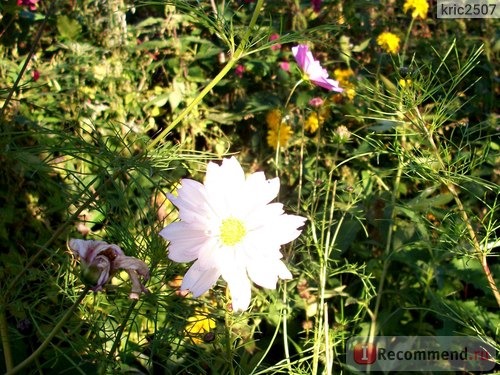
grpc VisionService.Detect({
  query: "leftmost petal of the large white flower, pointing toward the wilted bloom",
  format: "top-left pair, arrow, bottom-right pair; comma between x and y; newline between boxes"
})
160,222 -> 209,262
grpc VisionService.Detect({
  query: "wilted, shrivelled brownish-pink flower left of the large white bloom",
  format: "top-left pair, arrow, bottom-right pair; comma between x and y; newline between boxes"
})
69,238 -> 149,299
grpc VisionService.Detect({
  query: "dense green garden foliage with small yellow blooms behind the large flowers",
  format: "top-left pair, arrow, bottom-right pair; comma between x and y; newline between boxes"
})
0,0 -> 500,374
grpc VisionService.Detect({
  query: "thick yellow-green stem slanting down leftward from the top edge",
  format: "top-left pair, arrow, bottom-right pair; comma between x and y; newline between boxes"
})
146,0 -> 264,150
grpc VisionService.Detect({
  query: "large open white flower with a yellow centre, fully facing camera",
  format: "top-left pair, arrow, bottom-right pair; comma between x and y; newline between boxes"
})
160,157 -> 306,311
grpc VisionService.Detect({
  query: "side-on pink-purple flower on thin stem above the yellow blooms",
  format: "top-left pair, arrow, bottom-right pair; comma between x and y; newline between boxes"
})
292,44 -> 343,92
